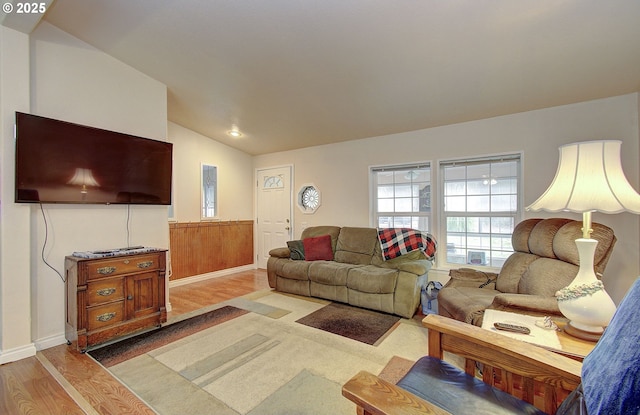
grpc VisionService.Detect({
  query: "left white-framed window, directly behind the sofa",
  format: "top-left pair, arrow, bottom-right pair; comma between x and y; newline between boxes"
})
371,163 -> 431,232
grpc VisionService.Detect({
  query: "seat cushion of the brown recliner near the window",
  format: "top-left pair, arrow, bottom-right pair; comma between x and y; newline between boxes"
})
438,287 -> 500,326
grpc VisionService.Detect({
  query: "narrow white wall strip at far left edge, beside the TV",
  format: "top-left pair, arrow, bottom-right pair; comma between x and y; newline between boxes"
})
0,26 -> 35,364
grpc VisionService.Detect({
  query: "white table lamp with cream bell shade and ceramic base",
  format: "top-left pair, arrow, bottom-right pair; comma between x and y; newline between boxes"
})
527,140 -> 640,341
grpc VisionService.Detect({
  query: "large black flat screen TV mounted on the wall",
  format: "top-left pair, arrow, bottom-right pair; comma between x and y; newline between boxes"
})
15,112 -> 173,205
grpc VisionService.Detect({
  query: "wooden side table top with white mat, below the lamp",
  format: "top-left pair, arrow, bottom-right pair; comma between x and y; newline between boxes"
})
482,310 -> 596,362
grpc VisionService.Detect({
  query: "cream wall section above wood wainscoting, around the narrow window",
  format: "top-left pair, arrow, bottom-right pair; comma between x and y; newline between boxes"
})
169,122 -> 255,222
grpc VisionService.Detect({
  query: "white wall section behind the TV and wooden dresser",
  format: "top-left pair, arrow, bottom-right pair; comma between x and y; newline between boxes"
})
26,22 -> 169,348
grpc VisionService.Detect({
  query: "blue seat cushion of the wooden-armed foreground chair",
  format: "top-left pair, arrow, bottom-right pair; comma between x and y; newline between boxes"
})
398,356 -> 544,415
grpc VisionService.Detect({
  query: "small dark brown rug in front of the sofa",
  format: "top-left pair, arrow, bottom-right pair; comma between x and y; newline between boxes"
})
297,303 -> 400,345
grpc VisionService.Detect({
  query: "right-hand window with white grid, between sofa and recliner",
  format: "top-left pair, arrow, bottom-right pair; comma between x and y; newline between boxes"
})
439,154 -> 522,267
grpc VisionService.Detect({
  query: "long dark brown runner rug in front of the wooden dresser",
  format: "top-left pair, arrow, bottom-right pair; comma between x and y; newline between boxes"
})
89,306 -> 248,367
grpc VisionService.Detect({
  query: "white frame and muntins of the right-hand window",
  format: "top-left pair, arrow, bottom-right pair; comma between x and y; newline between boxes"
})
437,151 -> 524,269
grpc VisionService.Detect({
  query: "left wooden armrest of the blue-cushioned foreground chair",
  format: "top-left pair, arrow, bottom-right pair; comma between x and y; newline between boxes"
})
342,371 -> 449,415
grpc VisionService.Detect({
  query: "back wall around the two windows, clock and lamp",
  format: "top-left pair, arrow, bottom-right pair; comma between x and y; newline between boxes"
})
254,93 -> 640,302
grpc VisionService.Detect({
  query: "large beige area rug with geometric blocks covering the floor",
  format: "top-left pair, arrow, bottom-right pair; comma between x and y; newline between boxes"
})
94,293 -> 427,415
